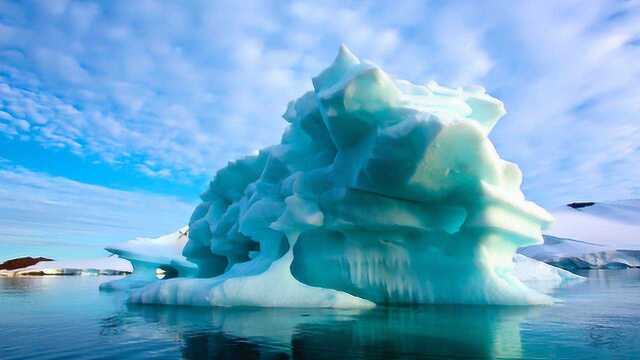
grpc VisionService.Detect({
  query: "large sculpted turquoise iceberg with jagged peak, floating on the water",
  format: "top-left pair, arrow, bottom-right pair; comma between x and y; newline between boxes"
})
131,46 -> 552,307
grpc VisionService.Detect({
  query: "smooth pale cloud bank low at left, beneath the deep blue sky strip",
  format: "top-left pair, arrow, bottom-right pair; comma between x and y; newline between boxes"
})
0,158 -> 194,253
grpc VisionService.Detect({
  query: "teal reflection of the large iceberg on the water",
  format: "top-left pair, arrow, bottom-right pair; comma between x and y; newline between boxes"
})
119,305 -> 536,359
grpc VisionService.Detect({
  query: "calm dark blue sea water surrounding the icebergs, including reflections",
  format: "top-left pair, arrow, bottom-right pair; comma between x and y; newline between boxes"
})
0,269 -> 640,360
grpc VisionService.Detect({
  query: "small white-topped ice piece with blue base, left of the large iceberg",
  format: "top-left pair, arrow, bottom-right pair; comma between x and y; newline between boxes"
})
100,226 -> 198,291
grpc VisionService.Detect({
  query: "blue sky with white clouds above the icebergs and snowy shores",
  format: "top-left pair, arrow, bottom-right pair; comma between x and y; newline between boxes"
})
0,0 -> 640,260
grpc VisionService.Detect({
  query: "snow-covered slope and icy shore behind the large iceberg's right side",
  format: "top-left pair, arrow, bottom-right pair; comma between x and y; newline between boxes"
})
519,200 -> 640,270
